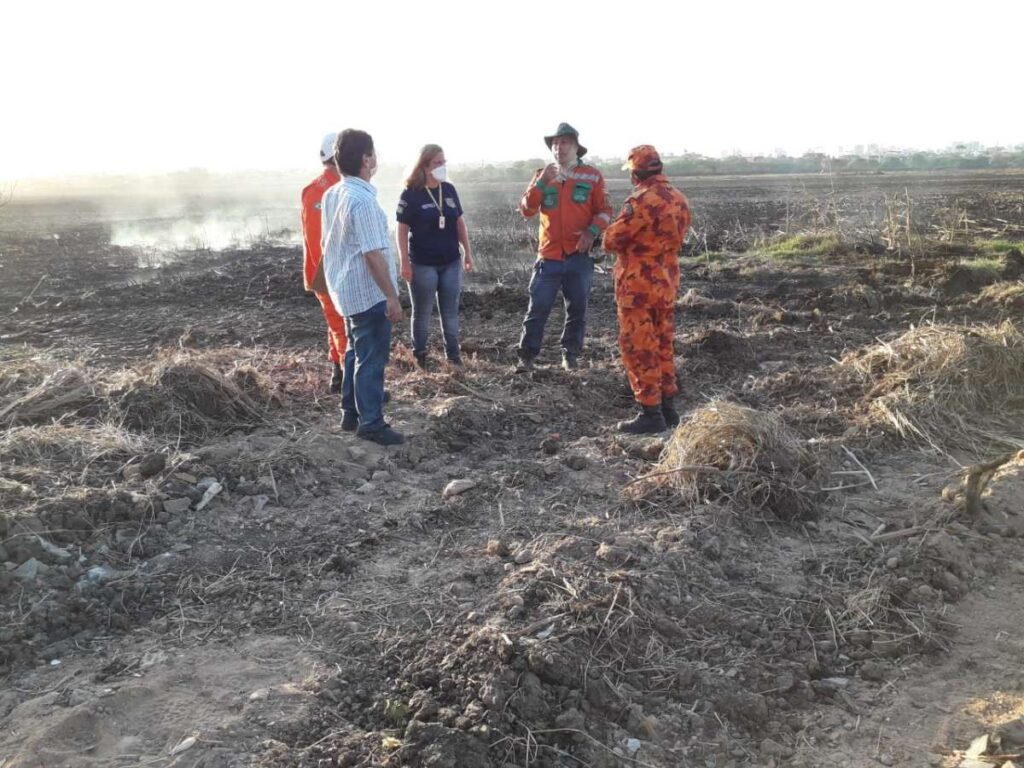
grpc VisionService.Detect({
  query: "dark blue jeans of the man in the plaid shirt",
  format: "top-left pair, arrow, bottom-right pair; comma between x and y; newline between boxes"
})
341,301 -> 391,434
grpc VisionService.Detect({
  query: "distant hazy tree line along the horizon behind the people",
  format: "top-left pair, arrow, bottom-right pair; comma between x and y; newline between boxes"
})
457,145 -> 1024,181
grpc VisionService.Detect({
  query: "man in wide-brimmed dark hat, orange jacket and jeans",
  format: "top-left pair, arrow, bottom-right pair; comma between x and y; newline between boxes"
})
516,123 -> 611,373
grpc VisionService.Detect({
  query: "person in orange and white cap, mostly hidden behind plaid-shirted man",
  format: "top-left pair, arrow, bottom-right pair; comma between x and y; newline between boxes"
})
302,133 -> 347,394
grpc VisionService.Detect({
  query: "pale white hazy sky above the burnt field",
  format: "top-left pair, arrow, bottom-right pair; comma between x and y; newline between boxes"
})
0,0 -> 1024,179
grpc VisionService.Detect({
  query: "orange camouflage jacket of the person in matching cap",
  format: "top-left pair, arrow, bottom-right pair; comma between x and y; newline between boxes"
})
604,174 -> 691,309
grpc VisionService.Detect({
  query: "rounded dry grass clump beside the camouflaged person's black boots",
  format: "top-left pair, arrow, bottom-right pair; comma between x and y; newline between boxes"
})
646,400 -> 820,519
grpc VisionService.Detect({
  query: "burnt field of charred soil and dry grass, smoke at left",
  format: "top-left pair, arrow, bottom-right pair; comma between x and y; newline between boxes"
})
0,173 -> 1024,768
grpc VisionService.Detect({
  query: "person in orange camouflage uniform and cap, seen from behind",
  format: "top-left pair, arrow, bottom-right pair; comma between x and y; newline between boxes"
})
604,144 -> 690,434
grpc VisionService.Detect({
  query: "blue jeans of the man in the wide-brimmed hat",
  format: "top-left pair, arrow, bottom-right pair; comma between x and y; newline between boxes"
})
519,253 -> 594,358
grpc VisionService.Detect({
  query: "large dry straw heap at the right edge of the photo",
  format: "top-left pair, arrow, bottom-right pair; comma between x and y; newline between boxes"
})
839,322 -> 1024,446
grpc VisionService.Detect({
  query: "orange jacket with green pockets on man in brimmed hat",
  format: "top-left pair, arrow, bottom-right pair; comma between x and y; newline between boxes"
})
519,162 -> 611,261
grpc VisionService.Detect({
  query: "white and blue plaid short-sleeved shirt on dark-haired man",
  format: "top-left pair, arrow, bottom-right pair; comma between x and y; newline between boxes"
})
321,176 -> 398,317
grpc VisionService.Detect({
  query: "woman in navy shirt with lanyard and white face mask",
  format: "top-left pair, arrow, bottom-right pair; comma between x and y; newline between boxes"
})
398,144 -> 473,368
